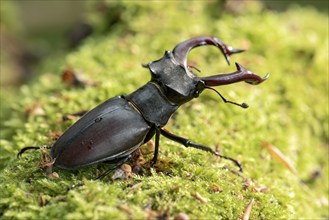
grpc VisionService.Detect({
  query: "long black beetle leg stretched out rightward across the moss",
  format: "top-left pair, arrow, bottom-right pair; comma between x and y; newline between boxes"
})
160,129 -> 243,172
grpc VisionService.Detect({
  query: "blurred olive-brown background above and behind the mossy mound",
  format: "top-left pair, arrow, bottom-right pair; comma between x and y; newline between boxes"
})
1,0 -> 328,87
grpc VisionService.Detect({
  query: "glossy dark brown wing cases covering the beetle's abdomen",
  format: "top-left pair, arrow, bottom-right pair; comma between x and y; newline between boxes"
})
51,97 -> 150,169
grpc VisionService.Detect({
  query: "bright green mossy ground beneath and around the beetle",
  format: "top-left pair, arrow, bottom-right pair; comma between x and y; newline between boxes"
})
0,1 -> 329,219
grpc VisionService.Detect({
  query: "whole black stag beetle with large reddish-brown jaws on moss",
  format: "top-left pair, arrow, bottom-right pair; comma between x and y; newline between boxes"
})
18,36 -> 269,179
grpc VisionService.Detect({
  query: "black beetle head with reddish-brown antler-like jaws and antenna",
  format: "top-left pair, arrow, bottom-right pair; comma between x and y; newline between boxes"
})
144,36 -> 269,107
